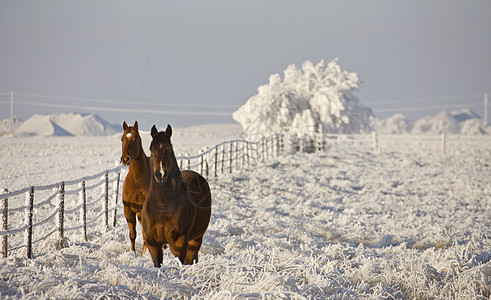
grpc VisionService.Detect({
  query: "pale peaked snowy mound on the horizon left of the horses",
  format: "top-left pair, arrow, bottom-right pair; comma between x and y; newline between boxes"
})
14,113 -> 119,136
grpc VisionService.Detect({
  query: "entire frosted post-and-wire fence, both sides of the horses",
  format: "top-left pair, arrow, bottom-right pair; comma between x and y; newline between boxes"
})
0,130 -> 491,258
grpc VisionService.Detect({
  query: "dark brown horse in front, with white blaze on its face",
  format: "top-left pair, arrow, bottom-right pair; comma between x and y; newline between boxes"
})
142,125 -> 211,267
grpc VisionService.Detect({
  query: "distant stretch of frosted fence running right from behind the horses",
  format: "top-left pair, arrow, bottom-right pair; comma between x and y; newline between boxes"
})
177,132 -> 491,179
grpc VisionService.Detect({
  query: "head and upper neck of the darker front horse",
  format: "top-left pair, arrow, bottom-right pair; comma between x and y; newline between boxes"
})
150,125 -> 181,184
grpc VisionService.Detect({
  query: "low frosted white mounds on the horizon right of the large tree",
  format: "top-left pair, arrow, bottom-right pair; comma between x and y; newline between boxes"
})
375,108 -> 491,135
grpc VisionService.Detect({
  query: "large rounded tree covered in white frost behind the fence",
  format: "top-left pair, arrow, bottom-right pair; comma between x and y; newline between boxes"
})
233,59 -> 374,137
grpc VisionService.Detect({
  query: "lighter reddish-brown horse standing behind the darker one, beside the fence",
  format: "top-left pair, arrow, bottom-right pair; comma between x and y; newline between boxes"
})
121,121 -> 152,252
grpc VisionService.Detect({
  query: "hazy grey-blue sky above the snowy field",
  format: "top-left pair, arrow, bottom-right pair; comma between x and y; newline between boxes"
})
0,0 -> 491,130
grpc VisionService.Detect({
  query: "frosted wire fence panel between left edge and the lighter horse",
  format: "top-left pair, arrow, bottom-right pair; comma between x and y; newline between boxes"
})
0,167 -> 121,258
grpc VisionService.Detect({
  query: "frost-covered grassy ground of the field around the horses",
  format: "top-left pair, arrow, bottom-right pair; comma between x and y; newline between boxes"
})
0,125 -> 491,299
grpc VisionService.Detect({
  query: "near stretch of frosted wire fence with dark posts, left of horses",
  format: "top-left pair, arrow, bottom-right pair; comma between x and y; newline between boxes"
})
0,166 -> 122,258
